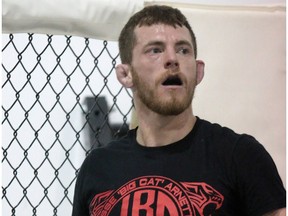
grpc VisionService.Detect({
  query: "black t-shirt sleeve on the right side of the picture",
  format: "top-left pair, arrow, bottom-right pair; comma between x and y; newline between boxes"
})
233,136 -> 286,216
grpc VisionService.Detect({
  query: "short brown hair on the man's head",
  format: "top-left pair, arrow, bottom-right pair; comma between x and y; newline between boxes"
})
118,5 -> 197,64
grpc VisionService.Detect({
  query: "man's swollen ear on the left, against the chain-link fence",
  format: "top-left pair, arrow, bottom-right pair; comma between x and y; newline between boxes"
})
116,64 -> 133,88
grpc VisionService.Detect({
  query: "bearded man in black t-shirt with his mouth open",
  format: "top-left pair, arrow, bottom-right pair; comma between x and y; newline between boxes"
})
73,6 -> 286,216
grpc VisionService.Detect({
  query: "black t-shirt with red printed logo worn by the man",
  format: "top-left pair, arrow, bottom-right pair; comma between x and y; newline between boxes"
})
73,118 -> 286,216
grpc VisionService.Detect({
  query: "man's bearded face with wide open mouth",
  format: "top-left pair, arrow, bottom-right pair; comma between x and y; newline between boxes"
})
131,24 -> 197,115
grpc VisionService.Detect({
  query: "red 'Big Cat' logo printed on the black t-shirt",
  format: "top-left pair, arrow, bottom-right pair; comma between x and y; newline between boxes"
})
90,176 -> 224,216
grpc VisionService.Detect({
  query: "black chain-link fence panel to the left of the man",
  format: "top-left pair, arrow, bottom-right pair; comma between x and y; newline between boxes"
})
2,34 -> 132,216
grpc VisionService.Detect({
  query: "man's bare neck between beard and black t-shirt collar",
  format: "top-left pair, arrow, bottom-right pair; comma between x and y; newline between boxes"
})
136,109 -> 196,147
